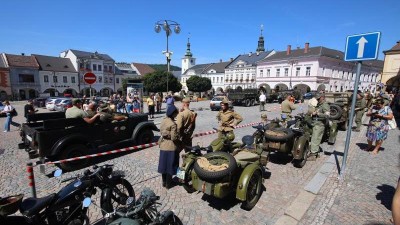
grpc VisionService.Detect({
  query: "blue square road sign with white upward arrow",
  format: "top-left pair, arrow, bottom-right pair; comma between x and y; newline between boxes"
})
344,32 -> 381,61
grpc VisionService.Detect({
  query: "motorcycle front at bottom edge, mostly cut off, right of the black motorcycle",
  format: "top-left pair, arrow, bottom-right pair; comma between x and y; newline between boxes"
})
97,188 -> 182,225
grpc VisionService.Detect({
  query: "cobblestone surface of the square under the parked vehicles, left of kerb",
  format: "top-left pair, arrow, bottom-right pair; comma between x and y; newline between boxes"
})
0,101 -> 334,225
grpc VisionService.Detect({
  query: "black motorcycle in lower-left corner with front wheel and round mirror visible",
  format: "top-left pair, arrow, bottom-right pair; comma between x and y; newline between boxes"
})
0,165 -> 135,225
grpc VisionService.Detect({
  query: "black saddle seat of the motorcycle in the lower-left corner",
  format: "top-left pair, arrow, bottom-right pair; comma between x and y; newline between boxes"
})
19,194 -> 56,217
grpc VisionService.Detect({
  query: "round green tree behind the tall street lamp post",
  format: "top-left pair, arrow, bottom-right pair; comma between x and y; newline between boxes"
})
143,71 -> 182,92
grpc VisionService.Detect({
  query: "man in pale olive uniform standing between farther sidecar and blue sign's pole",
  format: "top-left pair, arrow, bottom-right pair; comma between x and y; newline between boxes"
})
309,93 -> 330,161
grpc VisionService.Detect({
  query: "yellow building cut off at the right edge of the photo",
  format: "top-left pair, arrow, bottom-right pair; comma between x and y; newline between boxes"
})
382,41 -> 400,90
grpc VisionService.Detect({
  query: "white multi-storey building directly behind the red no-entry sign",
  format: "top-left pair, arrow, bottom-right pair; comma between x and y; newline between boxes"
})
60,49 -> 116,96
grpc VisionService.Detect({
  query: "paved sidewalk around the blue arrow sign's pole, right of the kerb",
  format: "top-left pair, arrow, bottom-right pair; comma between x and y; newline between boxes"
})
299,119 -> 400,225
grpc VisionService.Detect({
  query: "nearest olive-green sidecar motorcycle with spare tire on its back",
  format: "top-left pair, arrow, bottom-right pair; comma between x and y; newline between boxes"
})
186,135 -> 268,210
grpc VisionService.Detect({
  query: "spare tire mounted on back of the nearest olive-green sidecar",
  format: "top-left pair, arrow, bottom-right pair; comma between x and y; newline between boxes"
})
193,152 -> 237,183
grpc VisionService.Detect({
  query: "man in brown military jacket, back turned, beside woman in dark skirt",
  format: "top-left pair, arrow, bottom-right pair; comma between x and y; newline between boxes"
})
176,98 -> 197,151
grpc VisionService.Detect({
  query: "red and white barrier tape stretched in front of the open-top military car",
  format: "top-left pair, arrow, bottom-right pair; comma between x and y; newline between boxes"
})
41,122 -> 258,165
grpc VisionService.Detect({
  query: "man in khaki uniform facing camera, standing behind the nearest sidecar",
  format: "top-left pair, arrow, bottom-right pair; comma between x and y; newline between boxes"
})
217,99 -> 243,141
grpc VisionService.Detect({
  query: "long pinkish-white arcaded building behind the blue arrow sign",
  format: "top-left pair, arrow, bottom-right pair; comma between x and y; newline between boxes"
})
256,43 -> 383,92
